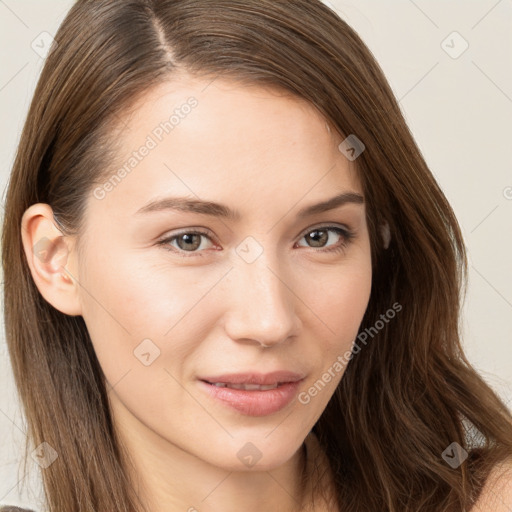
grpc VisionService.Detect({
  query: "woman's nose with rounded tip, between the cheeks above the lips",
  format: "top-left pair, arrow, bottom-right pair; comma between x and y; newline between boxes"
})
224,253 -> 301,347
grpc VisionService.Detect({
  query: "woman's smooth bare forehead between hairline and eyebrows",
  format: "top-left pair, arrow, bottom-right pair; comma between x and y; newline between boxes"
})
92,78 -> 361,221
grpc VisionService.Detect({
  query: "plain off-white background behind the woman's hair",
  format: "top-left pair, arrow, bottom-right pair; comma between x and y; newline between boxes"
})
0,0 -> 512,510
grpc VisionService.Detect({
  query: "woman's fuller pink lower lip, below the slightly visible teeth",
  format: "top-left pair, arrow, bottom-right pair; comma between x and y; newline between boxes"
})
199,380 -> 302,416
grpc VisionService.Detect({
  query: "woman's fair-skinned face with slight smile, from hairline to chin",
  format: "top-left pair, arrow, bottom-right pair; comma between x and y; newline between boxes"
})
77,79 -> 371,471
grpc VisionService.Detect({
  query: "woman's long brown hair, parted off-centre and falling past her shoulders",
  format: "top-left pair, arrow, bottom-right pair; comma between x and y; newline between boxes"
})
2,0 -> 512,512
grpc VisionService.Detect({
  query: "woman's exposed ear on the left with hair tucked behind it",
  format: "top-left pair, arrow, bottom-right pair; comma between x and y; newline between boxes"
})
21,203 -> 82,316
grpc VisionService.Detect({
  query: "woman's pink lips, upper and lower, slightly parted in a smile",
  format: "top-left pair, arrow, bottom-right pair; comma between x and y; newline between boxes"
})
199,371 -> 304,416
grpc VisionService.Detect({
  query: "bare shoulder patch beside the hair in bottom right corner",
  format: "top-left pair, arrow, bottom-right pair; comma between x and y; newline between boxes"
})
471,460 -> 512,512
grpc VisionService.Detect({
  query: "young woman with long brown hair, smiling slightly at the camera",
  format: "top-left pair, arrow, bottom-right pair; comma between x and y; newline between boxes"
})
3,0 -> 512,512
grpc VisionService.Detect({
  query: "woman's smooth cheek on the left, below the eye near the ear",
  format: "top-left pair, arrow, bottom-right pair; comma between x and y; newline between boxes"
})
77,246 -> 218,384
